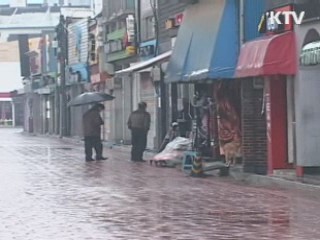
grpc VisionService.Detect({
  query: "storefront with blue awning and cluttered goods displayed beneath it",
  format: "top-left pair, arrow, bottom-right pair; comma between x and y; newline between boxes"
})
165,0 -> 241,158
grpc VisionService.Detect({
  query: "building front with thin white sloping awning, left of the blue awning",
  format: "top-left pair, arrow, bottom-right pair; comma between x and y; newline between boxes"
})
110,1 -> 186,149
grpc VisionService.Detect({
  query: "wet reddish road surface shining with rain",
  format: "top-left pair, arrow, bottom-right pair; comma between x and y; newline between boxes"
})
0,129 -> 320,240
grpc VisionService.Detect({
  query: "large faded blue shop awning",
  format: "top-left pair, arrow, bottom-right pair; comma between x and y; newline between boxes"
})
165,0 -> 239,83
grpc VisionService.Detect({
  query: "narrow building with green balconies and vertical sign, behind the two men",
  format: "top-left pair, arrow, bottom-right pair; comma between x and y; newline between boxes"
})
103,0 -> 137,144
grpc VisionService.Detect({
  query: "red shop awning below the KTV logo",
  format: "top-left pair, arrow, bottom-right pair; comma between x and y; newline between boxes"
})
235,32 -> 297,78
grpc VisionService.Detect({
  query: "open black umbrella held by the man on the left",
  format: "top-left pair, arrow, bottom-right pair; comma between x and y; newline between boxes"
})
68,92 -> 115,107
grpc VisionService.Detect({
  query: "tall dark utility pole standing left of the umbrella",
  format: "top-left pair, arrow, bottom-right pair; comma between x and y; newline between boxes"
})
56,15 -> 68,137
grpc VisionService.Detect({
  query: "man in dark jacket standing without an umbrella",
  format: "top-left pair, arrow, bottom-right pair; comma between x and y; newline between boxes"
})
128,102 -> 151,162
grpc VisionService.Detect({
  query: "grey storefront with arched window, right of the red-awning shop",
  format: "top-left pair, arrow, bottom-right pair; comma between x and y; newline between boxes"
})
295,19 -> 320,176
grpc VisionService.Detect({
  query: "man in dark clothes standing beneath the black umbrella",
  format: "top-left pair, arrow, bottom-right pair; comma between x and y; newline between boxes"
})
82,103 -> 107,161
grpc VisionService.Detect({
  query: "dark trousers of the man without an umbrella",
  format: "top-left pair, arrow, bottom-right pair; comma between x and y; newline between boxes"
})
131,129 -> 148,161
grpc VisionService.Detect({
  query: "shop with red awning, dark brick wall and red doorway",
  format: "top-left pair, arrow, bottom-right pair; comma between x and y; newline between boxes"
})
235,7 -> 297,174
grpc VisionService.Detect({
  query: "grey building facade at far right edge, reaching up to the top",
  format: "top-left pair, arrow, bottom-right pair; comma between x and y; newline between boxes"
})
288,1 -> 320,177
